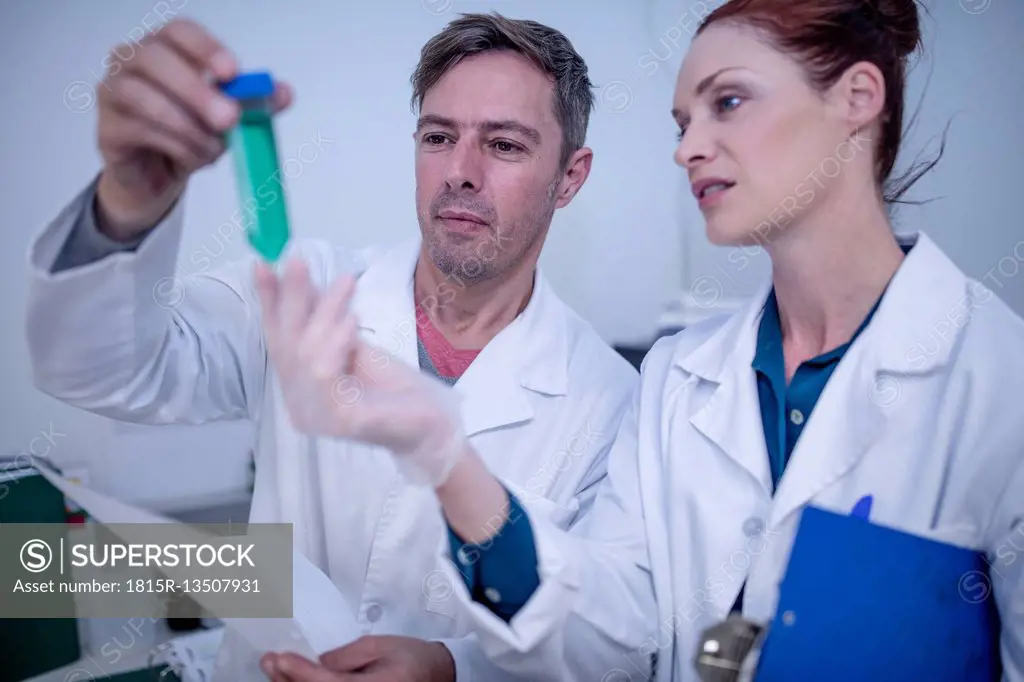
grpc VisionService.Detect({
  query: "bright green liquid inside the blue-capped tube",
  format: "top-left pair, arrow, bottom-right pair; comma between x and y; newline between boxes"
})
229,110 -> 289,262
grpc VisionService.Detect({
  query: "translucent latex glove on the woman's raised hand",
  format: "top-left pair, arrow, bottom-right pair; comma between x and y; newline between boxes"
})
256,259 -> 465,487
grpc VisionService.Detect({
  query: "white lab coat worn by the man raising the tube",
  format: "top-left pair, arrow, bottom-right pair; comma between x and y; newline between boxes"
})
28,178 -> 638,681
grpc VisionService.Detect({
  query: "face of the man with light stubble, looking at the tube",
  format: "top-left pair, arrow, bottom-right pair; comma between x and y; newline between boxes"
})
414,51 -> 567,281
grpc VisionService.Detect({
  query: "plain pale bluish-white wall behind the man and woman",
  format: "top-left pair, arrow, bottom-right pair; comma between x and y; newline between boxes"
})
0,0 -> 1024,506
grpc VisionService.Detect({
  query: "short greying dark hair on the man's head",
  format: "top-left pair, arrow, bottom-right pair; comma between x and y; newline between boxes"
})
410,12 -> 594,169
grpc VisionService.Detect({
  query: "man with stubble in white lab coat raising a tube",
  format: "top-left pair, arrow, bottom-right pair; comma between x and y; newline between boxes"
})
28,14 -> 637,682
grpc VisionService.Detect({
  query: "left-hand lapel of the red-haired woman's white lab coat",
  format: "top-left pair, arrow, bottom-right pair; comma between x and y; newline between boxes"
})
676,286 -> 771,496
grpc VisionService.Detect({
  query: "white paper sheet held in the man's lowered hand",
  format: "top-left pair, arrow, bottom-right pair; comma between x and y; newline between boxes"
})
39,458 -> 360,682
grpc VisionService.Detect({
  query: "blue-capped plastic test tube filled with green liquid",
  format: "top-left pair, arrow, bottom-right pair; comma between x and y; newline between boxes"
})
220,72 -> 289,262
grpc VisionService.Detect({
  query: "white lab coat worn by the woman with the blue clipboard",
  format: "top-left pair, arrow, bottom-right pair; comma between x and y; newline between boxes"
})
446,231 -> 1024,682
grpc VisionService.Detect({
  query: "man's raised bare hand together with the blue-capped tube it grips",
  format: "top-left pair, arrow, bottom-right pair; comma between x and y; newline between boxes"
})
96,19 -> 293,253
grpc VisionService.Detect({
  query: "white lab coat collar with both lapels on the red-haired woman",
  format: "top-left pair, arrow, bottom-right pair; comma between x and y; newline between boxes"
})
673,233 -> 970,497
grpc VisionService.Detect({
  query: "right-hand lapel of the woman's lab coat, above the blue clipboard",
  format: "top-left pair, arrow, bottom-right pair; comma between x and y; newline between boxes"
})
771,235 -> 968,527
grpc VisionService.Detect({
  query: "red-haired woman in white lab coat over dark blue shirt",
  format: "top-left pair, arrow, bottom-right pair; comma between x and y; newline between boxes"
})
256,0 -> 1024,681
